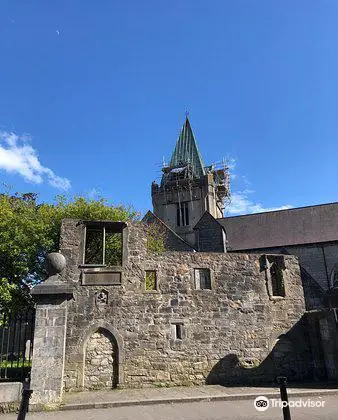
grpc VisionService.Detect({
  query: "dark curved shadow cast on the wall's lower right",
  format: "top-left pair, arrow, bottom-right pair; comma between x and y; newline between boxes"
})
206,317 -> 314,386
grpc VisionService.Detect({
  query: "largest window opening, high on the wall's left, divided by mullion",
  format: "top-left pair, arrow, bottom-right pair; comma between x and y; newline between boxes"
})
84,226 -> 122,267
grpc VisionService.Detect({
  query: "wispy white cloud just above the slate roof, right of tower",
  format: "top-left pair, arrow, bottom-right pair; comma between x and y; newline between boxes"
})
225,190 -> 293,215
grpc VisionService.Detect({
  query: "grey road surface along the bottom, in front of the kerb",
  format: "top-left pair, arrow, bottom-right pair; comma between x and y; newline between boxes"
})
0,395 -> 338,420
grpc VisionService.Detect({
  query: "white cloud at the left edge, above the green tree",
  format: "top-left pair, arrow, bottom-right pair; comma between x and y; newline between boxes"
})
0,131 -> 70,190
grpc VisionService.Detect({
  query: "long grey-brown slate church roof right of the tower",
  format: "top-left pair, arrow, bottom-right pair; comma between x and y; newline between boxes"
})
217,202 -> 338,251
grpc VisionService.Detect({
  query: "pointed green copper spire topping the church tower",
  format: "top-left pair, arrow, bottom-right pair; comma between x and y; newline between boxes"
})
170,117 -> 205,178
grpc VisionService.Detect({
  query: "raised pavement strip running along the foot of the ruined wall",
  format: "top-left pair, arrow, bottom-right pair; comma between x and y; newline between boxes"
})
58,383 -> 338,410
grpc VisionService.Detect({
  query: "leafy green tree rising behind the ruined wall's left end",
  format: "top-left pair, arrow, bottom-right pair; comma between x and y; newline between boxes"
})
0,193 -> 139,310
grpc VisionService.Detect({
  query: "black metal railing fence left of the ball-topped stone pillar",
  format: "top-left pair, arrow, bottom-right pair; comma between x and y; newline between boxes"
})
0,310 -> 35,382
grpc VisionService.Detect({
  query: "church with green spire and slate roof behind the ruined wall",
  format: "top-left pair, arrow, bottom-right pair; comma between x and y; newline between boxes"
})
149,117 -> 338,310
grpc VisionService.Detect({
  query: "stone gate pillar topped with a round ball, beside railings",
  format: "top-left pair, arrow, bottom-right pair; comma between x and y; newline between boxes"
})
31,253 -> 73,406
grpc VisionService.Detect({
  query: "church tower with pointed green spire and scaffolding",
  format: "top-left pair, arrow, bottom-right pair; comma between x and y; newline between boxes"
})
151,115 -> 230,245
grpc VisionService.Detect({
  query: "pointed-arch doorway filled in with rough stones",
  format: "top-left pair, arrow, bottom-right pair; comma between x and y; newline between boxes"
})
83,328 -> 119,389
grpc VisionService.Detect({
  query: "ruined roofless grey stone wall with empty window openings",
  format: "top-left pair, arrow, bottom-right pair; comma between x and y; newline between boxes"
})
61,219 -> 311,390
